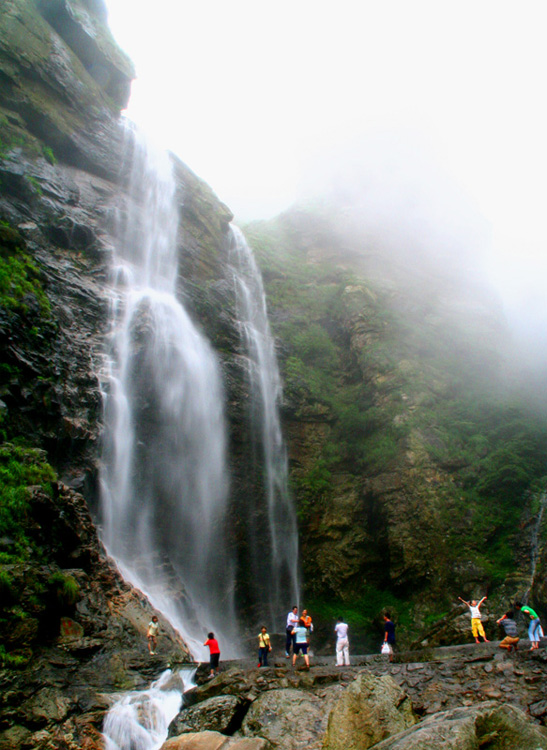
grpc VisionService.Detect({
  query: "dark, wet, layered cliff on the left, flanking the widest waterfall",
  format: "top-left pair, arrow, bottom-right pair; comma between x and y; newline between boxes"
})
0,0 -> 241,748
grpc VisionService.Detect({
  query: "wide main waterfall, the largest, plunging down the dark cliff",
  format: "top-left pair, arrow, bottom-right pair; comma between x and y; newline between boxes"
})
100,130 -> 238,658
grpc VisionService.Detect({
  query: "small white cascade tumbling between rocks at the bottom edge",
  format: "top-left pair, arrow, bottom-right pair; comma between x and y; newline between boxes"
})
103,669 -> 196,750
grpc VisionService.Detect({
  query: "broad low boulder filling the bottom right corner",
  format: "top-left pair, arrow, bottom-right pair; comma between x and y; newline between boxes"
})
368,702 -> 547,750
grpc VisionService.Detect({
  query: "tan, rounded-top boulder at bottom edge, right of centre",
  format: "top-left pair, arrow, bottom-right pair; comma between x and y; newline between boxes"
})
323,672 -> 417,750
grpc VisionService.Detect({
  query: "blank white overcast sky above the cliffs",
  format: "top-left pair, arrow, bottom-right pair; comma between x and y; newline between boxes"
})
107,0 -> 547,334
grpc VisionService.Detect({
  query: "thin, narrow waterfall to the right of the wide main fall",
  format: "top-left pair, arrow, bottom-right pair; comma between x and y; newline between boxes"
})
229,227 -> 299,631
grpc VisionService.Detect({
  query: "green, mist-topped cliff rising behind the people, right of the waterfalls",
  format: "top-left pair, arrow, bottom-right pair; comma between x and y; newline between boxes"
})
246,203 -> 546,647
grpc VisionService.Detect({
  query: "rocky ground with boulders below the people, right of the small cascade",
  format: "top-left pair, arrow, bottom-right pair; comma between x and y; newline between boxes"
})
163,642 -> 547,750
